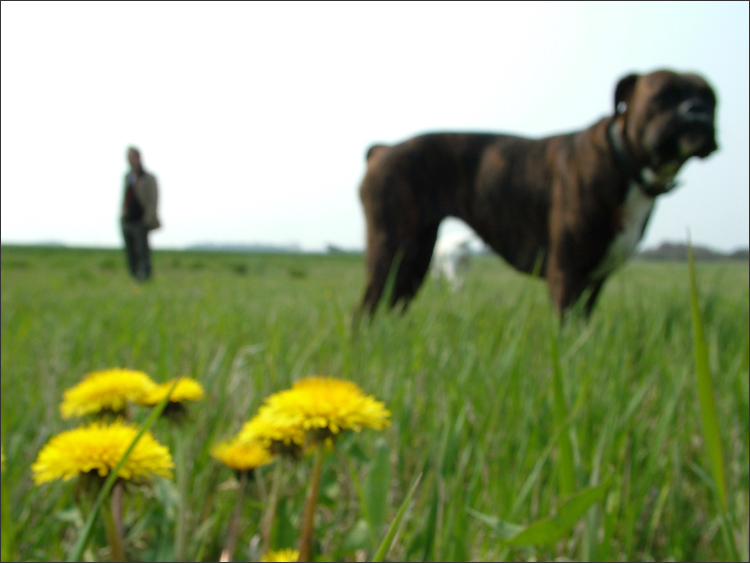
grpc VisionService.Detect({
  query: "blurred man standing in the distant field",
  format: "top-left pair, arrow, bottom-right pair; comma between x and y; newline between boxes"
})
120,147 -> 161,281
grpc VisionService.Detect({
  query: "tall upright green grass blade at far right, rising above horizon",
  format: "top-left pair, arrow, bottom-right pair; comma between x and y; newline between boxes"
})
688,244 -> 728,513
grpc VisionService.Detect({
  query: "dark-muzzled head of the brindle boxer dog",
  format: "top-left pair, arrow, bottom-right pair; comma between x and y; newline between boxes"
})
615,70 -> 718,182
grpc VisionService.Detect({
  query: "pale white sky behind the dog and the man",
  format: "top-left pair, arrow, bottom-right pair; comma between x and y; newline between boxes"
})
0,1 -> 750,250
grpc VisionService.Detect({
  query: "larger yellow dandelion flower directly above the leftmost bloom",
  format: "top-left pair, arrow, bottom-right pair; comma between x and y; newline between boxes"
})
60,369 -> 156,418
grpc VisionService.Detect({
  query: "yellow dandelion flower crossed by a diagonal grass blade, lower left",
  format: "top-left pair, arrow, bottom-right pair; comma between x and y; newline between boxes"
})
31,420 -> 174,485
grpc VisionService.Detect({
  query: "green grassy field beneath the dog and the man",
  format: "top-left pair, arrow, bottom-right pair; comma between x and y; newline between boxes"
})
2,247 -> 750,561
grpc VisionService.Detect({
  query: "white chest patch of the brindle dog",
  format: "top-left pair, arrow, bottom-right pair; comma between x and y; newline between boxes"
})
591,185 -> 654,279
